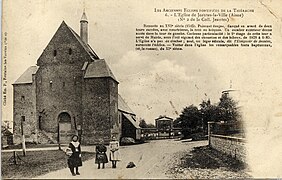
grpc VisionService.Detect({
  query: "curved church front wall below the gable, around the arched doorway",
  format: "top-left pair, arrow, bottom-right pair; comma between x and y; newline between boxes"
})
37,65 -> 82,136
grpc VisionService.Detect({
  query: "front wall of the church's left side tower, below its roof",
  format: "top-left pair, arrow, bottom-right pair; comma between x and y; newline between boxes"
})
13,80 -> 37,144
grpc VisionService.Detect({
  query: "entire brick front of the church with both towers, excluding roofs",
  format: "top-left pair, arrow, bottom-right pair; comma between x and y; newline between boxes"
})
14,22 -> 121,144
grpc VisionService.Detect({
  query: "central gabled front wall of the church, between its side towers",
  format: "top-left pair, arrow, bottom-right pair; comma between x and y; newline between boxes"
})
36,25 -> 90,139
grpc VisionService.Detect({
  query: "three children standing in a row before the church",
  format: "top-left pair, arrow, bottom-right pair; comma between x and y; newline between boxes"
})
67,135 -> 120,176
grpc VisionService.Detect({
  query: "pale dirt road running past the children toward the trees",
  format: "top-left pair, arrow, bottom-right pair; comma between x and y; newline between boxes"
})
36,139 -> 207,179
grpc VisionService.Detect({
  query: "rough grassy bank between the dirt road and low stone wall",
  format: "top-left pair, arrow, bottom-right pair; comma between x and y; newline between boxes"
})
171,146 -> 251,179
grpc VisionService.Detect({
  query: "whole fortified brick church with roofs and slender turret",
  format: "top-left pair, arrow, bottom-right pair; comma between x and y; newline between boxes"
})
13,12 -> 138,144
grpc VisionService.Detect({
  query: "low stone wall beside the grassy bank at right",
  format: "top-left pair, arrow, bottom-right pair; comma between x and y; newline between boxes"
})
209,134 -> 246,163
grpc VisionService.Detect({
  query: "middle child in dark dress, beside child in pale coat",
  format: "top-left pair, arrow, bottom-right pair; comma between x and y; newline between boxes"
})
95,140 -> 109,169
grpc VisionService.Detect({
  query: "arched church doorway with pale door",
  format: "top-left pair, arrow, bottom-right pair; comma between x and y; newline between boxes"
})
58,112 -> 72,144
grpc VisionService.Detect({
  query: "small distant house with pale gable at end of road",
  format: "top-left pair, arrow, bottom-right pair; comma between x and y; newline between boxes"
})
155,116 -> 173,137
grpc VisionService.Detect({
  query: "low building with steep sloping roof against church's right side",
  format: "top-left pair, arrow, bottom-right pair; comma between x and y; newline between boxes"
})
118,95 -> 141,141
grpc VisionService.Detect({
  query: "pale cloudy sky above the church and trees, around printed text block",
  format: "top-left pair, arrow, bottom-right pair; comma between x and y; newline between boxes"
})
2,0 -> 282,175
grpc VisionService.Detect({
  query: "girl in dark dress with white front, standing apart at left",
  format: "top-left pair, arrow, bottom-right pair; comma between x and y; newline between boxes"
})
68,135 -> 82,176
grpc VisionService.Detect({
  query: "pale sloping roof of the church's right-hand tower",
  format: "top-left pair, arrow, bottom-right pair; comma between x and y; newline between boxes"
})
84,59 -> 117,81
